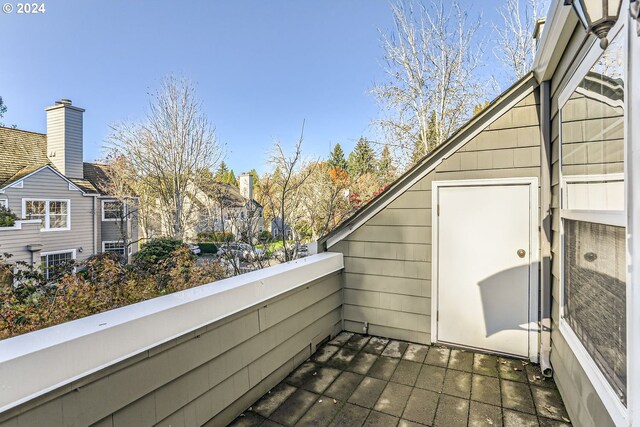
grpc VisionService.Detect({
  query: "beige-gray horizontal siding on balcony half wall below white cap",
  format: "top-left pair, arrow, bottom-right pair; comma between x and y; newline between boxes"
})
0,273 -> 342,427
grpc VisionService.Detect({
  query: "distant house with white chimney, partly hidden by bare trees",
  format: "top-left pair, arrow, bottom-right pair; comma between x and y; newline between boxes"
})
189,174 -> 264,241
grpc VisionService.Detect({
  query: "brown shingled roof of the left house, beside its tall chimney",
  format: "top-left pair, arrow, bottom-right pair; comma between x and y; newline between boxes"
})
0,126 -> 104,193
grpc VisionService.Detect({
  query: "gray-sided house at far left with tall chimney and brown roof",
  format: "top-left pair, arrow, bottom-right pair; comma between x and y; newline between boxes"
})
0,99 -> 137,278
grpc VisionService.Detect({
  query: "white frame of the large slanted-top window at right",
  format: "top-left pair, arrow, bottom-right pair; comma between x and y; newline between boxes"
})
558,18 -> 633,426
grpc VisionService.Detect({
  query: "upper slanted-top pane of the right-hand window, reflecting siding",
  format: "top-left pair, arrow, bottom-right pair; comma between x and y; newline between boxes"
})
561,37 -> 624,210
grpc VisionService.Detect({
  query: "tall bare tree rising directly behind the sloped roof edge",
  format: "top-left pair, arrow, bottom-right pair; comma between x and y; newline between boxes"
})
372,0 -> 484,167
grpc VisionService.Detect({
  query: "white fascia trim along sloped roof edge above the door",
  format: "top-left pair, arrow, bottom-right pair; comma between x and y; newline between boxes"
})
326,82 -> 535,249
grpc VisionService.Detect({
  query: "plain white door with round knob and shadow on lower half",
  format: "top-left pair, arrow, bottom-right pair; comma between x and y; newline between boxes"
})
434,183 -> 537,356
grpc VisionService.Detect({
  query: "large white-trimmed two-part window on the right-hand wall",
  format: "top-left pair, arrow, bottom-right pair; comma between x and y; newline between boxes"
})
558,23 -> 628,420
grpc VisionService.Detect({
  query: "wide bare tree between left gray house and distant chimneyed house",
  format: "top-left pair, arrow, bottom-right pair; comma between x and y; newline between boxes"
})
108,77 -> 221,240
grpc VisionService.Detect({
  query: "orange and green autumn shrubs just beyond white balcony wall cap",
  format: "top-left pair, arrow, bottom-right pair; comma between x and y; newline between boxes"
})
0,247 -> 225,339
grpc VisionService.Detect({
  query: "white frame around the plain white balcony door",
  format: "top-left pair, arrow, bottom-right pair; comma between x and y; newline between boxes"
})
431,177 -> 540,363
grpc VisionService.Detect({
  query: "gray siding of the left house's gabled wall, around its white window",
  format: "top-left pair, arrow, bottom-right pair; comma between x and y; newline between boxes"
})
0,168 -> 94,261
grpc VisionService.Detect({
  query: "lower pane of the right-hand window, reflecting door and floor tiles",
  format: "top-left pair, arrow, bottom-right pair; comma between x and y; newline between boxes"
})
564,220 -> 627,404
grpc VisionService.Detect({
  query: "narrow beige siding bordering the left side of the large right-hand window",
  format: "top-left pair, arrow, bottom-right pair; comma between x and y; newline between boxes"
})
551,27 -> 614,427
